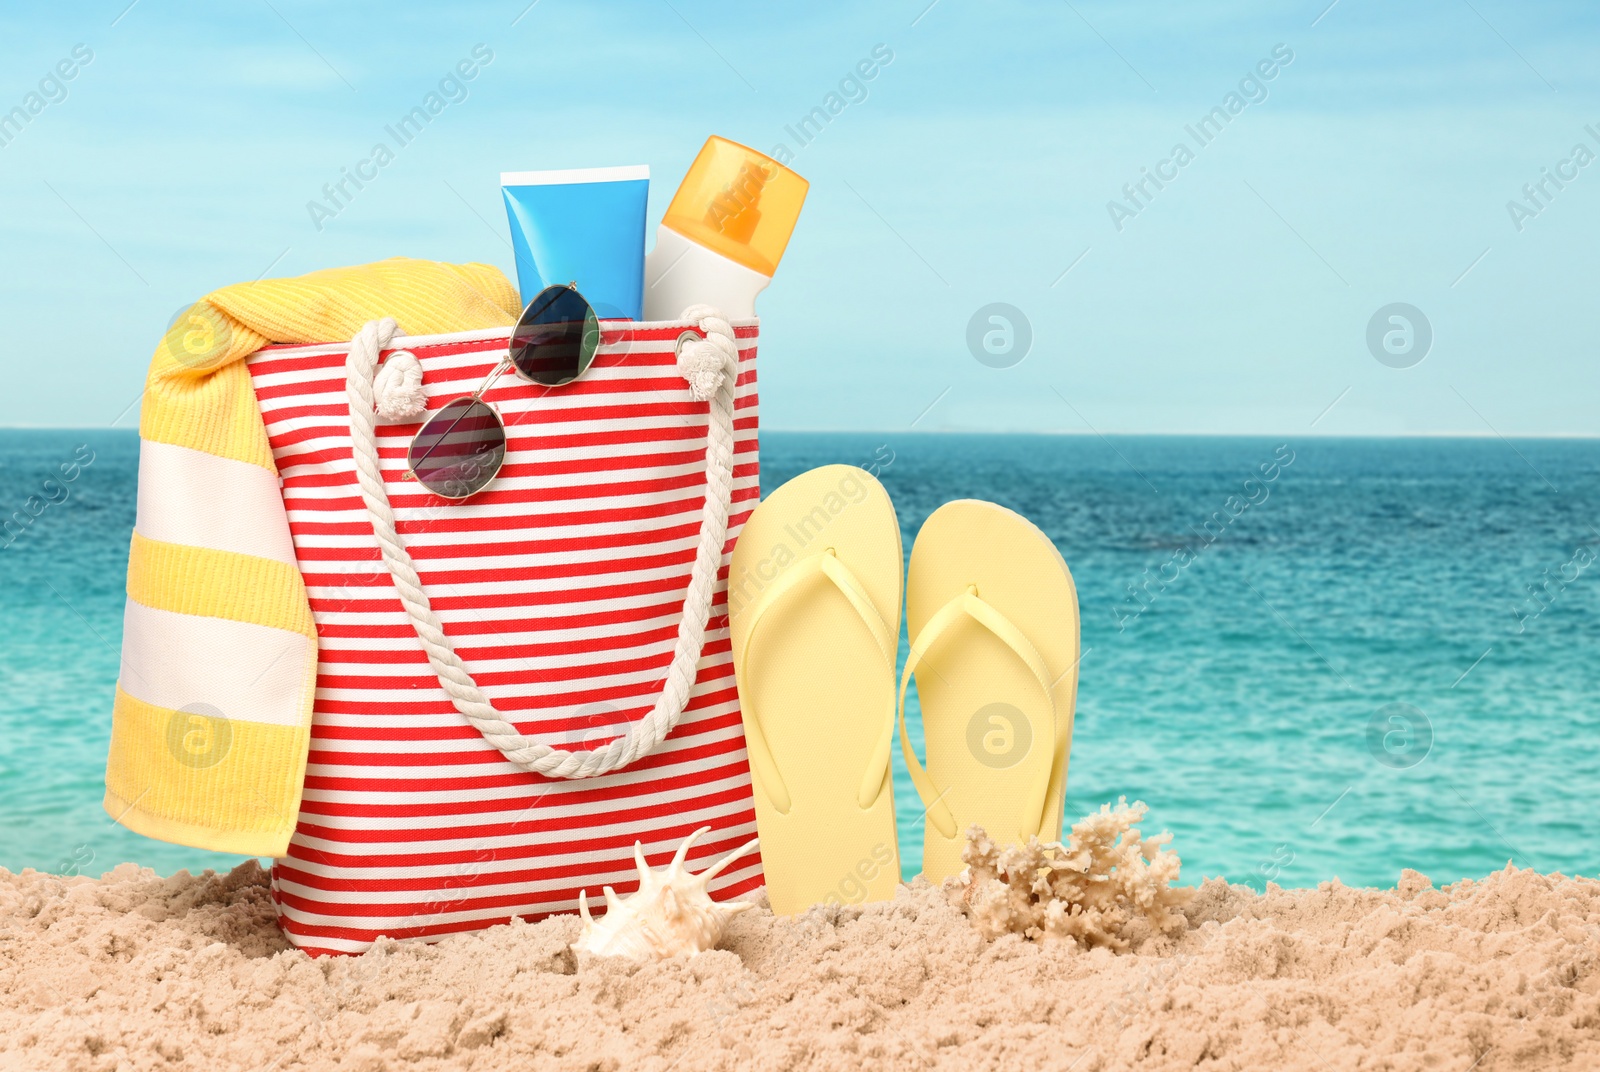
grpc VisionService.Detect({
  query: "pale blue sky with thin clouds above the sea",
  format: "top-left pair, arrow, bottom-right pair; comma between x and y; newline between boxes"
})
0,0 -> 1600,435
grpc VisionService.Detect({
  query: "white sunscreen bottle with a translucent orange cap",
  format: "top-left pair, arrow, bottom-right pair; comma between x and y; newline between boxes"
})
645,136 -> 811,320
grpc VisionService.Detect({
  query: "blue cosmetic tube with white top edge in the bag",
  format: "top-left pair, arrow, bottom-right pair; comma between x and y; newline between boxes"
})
501,165 -> 650,320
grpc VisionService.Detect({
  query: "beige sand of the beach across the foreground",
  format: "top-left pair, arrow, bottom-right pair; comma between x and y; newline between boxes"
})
0,862 -> 1600,1072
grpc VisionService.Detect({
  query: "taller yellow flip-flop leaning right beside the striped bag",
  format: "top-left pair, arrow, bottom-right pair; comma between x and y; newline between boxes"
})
728,466 -> 901,915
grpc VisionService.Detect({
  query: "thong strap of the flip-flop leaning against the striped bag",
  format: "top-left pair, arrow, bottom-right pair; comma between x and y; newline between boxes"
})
738,549 -> 898,814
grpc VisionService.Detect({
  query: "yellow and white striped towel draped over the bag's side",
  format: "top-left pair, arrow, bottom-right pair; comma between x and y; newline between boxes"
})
106,258 -> 520,856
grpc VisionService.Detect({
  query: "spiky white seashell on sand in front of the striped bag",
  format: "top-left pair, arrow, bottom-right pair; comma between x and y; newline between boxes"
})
573,826 -> 758,960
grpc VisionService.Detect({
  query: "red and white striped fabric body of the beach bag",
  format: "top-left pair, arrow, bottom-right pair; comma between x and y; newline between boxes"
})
248,322 -> 762,952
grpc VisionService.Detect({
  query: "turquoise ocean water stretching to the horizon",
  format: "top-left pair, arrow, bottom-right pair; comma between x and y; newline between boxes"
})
0,430 -> 1600,888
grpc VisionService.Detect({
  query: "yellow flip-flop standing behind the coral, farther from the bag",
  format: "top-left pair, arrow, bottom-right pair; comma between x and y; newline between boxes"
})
898,499 -> 1078,882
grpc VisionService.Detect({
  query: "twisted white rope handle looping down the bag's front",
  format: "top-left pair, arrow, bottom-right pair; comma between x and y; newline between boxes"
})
346,306 -> 739,778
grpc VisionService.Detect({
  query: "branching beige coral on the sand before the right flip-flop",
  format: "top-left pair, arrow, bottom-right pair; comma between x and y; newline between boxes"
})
946,797 -> 1194,952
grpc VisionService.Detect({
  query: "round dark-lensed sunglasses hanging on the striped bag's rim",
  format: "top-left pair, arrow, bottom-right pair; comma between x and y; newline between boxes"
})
406,283 -> 600,499
